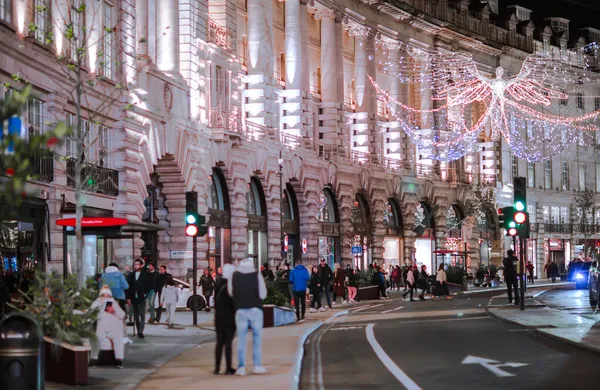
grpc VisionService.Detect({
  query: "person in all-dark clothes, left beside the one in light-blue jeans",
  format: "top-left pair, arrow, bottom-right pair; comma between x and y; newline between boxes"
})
214,264 -> 236,375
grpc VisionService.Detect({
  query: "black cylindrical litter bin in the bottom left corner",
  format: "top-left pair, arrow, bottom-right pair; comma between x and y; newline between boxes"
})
0,313 -> 44,390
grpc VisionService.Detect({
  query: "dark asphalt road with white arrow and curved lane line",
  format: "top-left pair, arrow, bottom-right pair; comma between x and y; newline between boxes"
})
301,291 -> 600,390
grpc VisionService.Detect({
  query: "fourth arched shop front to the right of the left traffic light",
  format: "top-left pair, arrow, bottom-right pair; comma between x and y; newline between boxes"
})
316,187 -> 340,269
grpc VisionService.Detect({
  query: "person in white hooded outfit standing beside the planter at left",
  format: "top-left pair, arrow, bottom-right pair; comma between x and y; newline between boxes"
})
91,285 -> 125,368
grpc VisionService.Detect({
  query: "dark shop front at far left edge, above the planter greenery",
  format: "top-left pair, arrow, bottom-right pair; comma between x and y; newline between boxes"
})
0,199 -> 50,272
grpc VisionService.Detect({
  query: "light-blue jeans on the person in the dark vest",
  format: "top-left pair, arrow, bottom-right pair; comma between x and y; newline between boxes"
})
235,308 -> 263,367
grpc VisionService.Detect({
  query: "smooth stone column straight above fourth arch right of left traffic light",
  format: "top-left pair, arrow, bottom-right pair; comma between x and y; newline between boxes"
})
315,9 -> 339,102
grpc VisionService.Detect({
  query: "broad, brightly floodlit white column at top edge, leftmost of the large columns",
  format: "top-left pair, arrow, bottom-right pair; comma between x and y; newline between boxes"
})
156,0 -> 179,73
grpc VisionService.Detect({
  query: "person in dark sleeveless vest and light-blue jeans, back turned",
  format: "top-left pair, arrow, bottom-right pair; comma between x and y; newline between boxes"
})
227,259 -> 267,376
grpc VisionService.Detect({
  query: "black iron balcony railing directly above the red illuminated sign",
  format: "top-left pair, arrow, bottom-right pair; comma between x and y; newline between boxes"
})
67,158 -> 119,196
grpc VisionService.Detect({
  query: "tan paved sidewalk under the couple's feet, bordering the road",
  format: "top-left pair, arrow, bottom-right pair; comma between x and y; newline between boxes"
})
138,308 -> 344,390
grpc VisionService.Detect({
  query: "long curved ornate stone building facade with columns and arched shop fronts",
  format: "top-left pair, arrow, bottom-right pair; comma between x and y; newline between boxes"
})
0,0 -> 600,276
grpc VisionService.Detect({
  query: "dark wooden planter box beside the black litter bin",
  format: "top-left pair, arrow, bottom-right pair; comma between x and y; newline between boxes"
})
44,337 -> 91,386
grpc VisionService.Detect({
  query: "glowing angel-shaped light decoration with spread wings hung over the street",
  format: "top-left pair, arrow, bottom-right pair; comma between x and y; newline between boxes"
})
371,45 -> 600,162
